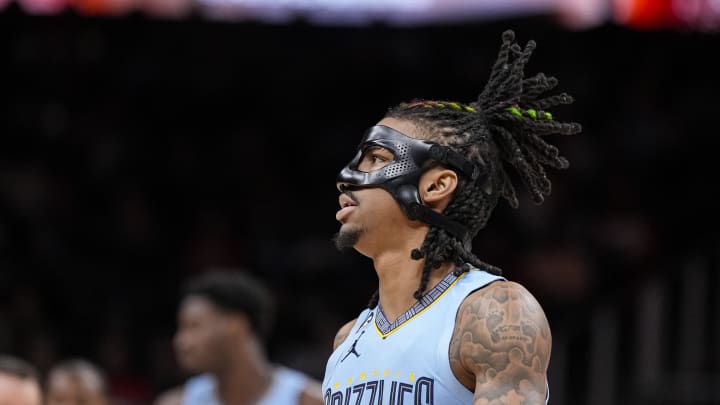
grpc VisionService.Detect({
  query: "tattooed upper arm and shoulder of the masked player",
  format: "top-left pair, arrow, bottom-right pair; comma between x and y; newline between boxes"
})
449,281 -> 552,405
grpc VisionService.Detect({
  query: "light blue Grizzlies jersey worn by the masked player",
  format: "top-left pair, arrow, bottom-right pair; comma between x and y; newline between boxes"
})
323,269 -> 504,405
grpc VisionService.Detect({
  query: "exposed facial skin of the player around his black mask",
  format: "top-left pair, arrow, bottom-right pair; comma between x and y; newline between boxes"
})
335,118 -> 418,255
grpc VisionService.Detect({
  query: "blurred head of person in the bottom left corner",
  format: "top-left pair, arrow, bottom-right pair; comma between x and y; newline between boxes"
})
0,355 -> 42,405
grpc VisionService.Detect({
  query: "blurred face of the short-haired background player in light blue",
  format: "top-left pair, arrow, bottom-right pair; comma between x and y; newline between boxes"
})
174,295 -> 228,372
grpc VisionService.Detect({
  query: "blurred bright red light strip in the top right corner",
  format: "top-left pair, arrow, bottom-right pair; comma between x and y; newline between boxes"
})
614,0 -> 720,31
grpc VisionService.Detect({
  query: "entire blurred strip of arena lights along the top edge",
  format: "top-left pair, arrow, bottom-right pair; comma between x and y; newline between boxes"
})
5,0 -> 720,31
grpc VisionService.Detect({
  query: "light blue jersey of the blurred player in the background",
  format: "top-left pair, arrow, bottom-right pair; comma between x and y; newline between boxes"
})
182,367 -> 308,405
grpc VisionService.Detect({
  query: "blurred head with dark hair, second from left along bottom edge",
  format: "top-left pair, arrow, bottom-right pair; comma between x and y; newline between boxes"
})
46,359 -> 110,405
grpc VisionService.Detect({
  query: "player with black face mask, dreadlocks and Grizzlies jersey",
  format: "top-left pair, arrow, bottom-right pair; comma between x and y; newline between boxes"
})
323,31 -> 580,405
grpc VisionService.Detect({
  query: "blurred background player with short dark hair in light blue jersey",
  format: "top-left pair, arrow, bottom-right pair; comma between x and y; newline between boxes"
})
156,272 -> 323,405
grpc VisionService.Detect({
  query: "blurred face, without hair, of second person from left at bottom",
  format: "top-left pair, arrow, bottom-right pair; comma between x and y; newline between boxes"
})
47,371 -> 107,405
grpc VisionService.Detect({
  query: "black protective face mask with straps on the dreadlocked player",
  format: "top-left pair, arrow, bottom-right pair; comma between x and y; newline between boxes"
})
337,125 -> 485,245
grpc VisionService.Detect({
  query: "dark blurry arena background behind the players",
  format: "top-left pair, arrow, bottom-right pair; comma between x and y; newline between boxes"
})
0,0 -> 720,404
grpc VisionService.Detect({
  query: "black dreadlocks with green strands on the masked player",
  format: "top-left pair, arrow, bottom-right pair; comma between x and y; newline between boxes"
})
369,30 -> 581,308
